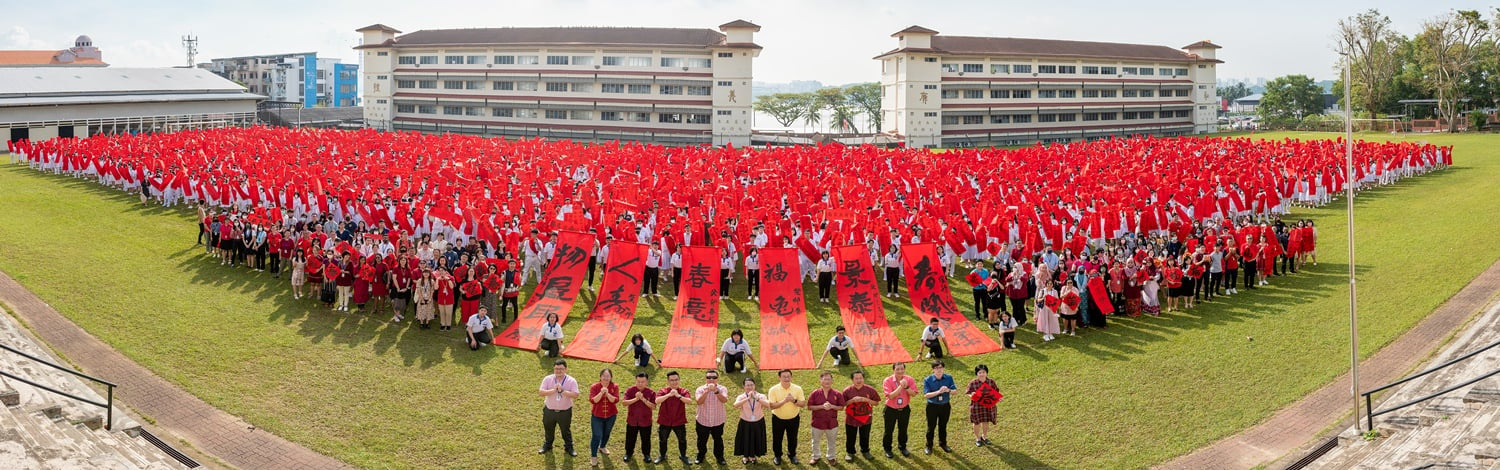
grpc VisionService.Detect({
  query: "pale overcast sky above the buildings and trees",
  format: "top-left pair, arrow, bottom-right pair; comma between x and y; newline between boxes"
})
0,0 -> 1490,84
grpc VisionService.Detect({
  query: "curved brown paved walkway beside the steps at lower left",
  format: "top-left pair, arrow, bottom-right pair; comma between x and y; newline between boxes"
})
0,273 -> 348,470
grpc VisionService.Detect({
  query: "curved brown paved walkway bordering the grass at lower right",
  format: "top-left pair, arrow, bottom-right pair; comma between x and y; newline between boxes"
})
1161,261 -> 1500,468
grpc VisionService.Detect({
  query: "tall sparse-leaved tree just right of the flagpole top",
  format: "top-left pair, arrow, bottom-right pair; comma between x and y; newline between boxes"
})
1334,9 -> 1406,117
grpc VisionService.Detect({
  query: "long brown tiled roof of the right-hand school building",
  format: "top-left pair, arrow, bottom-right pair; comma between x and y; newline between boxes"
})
876,36 -> 1218,62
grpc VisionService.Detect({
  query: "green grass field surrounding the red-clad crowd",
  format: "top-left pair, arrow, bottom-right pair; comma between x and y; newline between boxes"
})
0,134 -> 1500,468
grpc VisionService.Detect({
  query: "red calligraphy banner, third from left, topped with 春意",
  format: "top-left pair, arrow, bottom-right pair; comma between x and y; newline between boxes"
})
662,246 -> 719,369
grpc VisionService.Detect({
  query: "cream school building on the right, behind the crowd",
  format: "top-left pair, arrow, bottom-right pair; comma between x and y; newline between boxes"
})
875,26 -> 1223,147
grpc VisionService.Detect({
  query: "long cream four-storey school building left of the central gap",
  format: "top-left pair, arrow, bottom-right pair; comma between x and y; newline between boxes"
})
356,20 -> 761,146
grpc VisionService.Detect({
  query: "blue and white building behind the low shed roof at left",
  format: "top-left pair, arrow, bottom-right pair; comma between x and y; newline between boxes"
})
200,53 -> 360,108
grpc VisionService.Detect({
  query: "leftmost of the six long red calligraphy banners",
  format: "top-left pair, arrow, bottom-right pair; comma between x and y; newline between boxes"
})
495,231 -> 594,351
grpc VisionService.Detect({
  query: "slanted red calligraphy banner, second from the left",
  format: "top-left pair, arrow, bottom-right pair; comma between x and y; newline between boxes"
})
563,240 -> 647,362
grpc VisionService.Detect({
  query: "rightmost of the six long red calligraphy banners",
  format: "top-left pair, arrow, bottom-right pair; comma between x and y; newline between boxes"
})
902,243 -> 1001,356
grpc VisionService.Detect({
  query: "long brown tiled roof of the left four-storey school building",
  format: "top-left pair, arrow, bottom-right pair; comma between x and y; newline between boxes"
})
369,27 -> 725,48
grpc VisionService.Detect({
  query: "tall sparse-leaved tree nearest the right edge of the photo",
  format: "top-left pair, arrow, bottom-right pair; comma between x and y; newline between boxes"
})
1415,11 -> 1490,132
